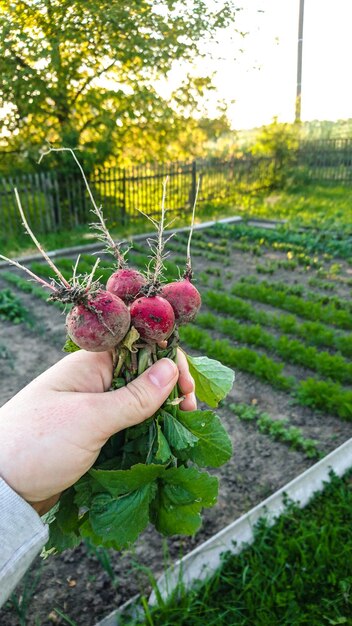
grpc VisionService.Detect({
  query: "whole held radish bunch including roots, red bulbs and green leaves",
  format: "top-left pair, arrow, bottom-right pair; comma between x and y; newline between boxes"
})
0,151 -> 234,551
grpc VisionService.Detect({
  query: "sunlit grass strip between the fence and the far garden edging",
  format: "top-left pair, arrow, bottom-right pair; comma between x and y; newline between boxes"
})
0,183 -> 352,256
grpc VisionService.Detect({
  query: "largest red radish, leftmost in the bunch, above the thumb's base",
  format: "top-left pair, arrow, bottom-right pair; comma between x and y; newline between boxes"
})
66,289 -> 130,352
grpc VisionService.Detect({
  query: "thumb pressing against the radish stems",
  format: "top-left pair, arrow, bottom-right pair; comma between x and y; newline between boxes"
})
93,359 -> 178,437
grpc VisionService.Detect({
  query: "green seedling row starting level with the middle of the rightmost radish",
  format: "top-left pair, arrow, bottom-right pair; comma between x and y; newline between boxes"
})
203,290 -> 352,358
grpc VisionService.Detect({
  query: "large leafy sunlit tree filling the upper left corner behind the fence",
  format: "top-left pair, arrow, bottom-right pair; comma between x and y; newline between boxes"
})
0,0 -> 235,167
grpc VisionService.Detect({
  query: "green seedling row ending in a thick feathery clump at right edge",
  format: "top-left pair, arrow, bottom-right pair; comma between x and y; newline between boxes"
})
180,325 -> 352,421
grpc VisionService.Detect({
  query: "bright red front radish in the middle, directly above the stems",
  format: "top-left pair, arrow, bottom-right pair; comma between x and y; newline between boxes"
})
130,296 -> 175,343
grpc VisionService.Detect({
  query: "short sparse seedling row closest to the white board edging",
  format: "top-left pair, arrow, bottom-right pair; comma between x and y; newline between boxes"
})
229,403 -> 324,459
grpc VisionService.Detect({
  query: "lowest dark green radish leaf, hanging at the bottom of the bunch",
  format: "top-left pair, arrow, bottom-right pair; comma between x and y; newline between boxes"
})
89,480 -> 157,549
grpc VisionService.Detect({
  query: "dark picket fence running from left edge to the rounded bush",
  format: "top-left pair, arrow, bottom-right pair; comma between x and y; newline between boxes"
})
0,156 -> 275,236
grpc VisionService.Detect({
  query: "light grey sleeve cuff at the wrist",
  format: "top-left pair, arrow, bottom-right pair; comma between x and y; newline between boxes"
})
0,478 -> 49,607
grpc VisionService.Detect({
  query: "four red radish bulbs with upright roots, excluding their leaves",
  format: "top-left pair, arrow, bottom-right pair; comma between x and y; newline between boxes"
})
67,181 -> 201,360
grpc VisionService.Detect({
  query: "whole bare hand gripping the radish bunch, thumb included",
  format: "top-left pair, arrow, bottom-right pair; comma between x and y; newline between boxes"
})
0,350 -> 196,515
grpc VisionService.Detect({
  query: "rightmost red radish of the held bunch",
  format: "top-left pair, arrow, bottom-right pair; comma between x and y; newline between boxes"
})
160,278 -> 202,326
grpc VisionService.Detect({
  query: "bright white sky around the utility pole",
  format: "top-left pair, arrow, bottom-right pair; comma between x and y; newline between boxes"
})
158,0 -> 352,129
